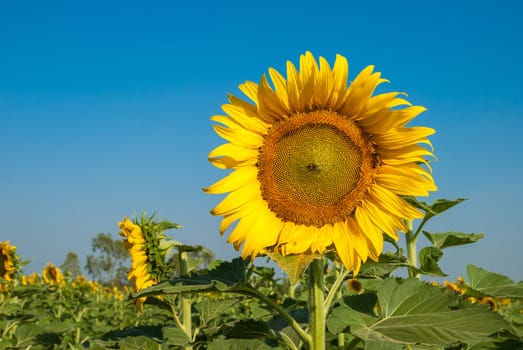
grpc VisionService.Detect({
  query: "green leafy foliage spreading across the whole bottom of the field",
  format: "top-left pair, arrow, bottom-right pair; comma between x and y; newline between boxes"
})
0,198 -> 523,350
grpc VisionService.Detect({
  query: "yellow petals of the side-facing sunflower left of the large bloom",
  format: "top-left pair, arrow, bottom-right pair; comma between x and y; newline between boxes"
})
118,218 -> 157,312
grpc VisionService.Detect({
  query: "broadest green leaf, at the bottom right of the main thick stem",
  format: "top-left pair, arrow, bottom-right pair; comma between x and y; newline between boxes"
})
327,279 -> 509,346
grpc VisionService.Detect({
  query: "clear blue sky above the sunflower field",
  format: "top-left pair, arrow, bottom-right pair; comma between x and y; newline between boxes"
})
0,0 -> 523,280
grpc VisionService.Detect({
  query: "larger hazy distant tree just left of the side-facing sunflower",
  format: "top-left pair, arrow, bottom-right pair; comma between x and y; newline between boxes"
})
85,233 -> 130,286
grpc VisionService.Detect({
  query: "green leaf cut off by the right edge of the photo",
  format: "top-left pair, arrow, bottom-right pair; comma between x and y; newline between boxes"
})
467,265 -> 523,298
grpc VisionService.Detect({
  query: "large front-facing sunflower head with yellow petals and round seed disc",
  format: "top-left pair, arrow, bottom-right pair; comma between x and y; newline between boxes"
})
204,52 -> 436,273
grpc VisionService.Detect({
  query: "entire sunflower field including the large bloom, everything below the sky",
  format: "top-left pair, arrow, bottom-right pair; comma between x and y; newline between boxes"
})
0,52 -> 523,350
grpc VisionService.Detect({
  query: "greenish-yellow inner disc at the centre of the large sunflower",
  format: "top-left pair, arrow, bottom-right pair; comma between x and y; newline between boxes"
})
273,124 -> 362,206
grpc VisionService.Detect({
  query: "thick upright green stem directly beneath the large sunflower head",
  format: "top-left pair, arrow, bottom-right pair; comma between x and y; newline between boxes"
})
309,259 -> 325,350
